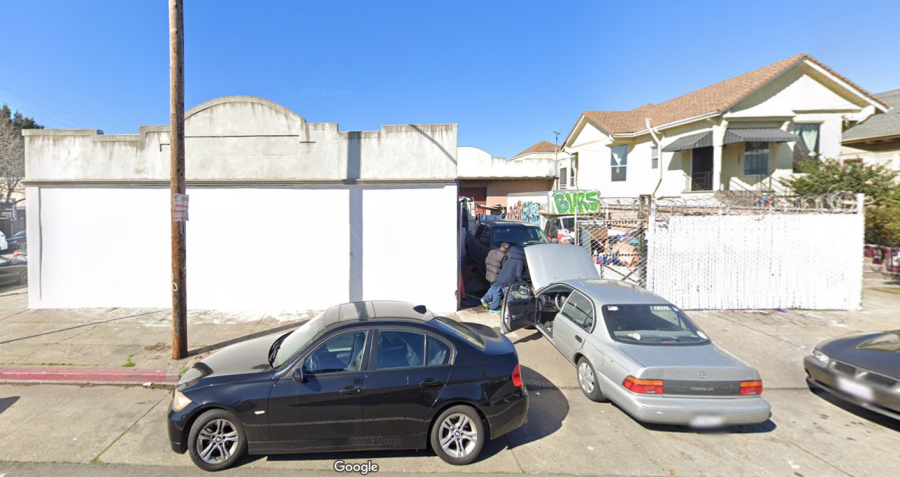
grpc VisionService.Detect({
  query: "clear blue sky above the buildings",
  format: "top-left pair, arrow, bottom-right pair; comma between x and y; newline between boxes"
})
0,0 -> 900,157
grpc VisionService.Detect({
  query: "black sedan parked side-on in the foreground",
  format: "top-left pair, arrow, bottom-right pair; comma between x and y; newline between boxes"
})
168,301 -> 528,470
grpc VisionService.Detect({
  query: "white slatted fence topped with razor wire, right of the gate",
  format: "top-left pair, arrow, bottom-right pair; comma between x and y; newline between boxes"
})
647,213 -> 863,310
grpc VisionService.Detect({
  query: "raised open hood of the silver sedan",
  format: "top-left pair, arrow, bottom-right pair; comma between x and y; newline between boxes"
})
525,243 -> 600,290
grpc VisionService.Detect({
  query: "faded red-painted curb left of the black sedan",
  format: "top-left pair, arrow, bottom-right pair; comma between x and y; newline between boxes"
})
0,366 -> 180,387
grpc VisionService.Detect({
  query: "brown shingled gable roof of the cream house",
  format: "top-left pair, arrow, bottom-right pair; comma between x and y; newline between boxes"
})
563,53 -> 888,144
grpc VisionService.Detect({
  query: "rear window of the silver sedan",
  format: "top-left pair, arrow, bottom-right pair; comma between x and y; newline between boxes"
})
602,305 -> 709,346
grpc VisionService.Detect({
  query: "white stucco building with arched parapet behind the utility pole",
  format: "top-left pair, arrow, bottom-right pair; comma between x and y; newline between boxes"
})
25,96 -> 459,311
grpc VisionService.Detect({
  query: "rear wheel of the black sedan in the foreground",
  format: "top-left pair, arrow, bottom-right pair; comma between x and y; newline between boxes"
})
431,405 -> 488,465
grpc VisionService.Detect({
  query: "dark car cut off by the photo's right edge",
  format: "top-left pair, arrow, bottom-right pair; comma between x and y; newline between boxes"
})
803,330 -> 900,419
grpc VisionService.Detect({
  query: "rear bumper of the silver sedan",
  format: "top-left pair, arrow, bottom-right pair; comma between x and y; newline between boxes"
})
615,393 -> 772,428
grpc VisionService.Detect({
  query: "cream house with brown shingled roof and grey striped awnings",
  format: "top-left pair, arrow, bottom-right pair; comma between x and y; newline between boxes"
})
563,54 -> 889,197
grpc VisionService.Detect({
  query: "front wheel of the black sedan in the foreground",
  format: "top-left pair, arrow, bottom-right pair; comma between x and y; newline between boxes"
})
188,409 -> 247,472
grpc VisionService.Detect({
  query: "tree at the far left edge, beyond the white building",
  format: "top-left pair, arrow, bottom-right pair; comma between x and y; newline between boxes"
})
0,104 -> 44,204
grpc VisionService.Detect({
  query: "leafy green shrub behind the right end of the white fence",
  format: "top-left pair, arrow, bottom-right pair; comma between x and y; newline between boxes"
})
780,159 -> 900,247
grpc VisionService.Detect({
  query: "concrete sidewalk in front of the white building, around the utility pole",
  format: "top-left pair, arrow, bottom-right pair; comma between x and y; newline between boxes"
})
0,286 -> 313,384
